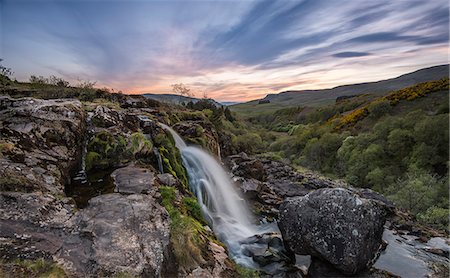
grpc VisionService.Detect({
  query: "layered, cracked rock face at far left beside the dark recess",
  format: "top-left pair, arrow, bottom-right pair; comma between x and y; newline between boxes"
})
0,96 -> 85,195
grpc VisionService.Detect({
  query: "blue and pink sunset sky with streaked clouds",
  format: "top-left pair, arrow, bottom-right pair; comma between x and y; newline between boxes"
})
0,0 -> 449,101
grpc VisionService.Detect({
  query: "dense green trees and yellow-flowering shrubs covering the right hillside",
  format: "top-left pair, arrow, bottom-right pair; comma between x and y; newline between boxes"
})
261,80 -> 449,227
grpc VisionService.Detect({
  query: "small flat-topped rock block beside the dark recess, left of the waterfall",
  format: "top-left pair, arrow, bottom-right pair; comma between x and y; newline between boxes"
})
111,165 -> 155,194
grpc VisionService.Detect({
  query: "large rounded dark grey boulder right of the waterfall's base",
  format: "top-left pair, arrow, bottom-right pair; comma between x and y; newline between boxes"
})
279,188 -> 386,274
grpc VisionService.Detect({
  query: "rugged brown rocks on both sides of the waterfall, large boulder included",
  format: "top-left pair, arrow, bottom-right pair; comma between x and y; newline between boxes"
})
0,96 -> 449,277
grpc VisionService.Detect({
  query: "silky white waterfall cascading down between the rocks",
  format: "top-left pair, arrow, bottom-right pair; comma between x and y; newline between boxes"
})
161,124 -> 274,268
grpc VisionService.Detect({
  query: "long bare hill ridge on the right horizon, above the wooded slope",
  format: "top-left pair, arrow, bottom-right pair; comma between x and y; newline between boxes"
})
230,65 -> 449,116
